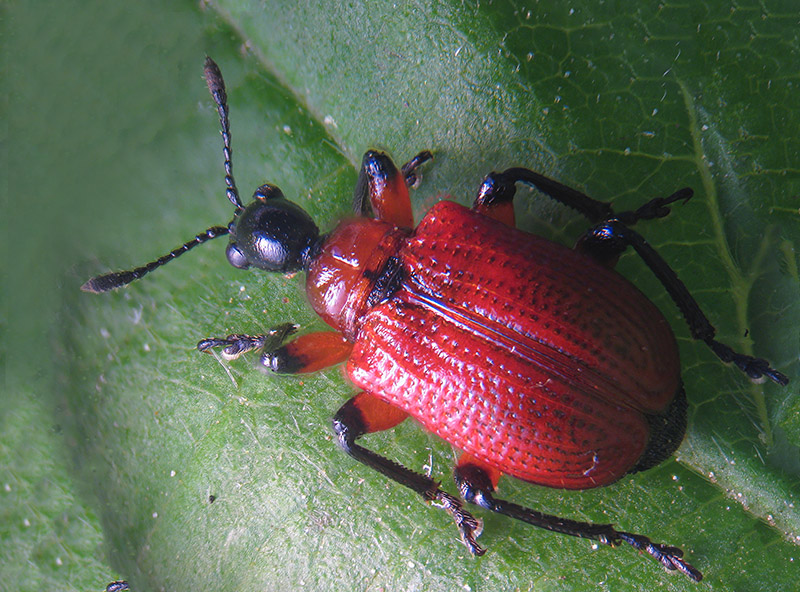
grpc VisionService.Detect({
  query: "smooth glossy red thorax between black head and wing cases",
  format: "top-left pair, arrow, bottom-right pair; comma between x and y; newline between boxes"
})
306,218 -> 410,340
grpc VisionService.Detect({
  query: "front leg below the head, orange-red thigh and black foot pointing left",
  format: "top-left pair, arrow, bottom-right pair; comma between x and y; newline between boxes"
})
197,323 -> 353,374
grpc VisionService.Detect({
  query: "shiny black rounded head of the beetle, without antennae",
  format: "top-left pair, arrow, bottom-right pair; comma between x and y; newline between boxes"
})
226,185 -> 319,273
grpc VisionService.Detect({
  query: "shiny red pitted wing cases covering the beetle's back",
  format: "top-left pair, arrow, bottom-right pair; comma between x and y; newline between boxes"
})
344,201 -> 680,489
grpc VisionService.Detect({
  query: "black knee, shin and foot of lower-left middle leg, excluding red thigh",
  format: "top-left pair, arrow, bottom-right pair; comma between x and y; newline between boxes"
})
333,397 -> 485,555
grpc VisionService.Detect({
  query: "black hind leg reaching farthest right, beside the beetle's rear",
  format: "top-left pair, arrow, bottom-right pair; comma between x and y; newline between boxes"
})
579,220 -> 789,386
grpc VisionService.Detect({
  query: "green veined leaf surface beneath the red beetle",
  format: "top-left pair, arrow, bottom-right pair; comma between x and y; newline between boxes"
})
9,2 -> 800,590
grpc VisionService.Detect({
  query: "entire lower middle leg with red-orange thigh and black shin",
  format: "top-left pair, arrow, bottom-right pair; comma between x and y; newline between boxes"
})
333,392 -> 485,555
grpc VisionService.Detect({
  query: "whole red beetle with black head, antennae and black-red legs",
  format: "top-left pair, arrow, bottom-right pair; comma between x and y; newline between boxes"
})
83,58 -> 788,581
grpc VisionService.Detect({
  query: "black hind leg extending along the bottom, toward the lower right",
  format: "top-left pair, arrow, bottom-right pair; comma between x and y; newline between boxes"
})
455,464 -> 703,582
